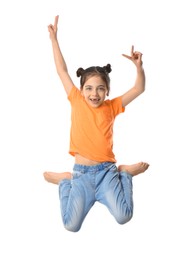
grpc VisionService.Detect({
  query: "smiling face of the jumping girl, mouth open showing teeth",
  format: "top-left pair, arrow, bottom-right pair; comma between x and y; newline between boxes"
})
81,76 -> 108,108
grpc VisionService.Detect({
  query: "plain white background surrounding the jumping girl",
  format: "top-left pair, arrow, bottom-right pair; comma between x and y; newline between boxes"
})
0,0 -> 195,260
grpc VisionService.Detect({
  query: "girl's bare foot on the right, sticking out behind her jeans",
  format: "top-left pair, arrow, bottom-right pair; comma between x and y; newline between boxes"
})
118,162 -> 149,176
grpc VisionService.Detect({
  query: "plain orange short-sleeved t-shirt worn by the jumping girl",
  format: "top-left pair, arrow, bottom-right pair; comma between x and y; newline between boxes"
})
68,87 -> 125,162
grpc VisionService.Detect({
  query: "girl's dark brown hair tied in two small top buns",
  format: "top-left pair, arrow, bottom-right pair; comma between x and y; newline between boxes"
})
76,64 -> 112,95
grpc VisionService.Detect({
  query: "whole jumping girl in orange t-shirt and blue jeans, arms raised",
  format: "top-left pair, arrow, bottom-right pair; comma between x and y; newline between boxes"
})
44,16 -> 149,232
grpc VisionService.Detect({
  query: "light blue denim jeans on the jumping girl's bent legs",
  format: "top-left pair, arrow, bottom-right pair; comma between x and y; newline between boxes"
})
59,162 -> 133,232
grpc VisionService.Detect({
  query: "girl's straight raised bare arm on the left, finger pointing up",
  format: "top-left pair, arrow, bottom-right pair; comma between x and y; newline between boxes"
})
48,15 -> 74,95
